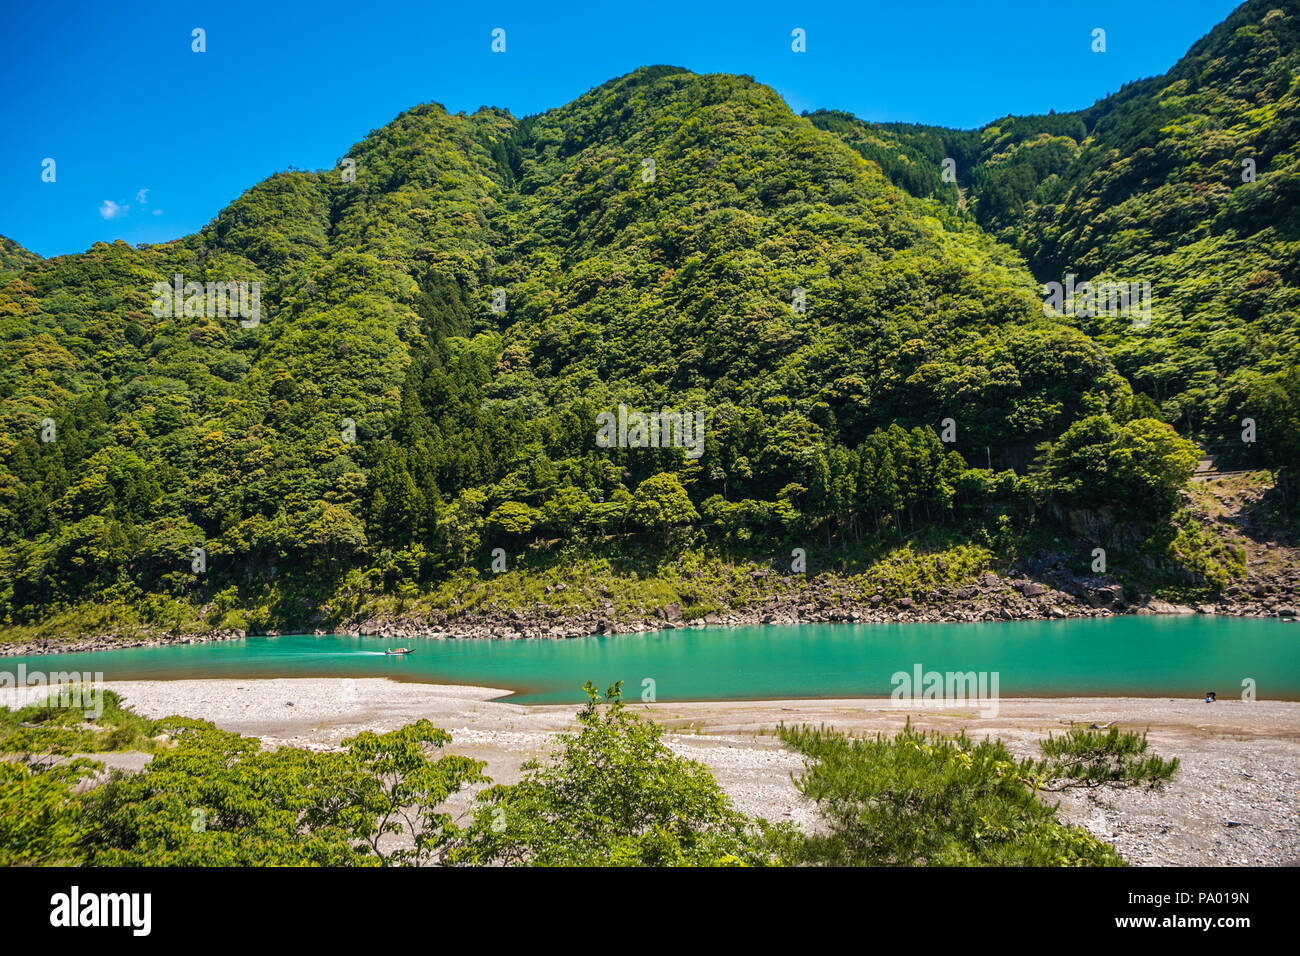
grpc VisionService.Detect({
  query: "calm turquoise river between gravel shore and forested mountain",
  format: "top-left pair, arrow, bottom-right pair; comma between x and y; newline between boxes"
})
0,617 -> 1300,704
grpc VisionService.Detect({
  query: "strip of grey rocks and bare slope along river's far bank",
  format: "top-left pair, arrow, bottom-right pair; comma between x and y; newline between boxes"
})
10,475 -> 1300,656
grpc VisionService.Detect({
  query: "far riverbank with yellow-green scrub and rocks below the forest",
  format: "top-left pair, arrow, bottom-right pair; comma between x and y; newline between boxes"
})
10,429 -> 1300,658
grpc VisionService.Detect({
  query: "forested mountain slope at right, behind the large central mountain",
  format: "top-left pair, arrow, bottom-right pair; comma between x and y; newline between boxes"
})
810,0 -> 1300,466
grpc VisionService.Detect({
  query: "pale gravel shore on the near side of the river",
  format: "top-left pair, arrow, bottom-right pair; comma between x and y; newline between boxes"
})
0,678 -> 1300,866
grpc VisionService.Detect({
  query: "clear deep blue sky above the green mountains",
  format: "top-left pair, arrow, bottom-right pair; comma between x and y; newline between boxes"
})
0,0 -> 1238,256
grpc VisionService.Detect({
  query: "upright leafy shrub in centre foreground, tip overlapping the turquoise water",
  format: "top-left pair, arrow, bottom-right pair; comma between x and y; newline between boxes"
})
452,682 -> 777,866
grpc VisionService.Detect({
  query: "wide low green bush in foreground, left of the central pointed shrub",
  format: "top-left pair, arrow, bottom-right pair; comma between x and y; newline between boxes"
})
78,718 -> 486,866
